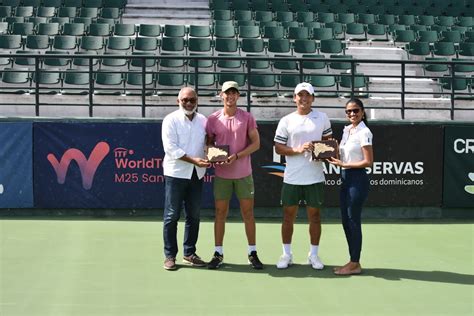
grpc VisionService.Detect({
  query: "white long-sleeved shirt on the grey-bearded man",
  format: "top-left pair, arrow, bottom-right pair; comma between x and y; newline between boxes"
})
161,110 -> 207,179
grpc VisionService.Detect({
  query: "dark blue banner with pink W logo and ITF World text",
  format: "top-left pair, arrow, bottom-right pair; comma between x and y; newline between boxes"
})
34,123 -> 213,208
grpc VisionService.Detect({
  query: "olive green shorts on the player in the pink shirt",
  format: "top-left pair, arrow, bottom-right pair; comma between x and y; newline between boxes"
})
214,175 -> 255,200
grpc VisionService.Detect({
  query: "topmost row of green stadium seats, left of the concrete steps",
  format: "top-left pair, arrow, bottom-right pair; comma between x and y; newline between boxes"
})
0,0 -> 127,9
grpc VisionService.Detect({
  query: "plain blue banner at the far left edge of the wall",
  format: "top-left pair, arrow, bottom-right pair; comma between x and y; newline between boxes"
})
0,122 -> 33,208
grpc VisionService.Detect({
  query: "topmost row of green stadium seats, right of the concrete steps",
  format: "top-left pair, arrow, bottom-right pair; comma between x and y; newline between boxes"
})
210,0 -> 474,16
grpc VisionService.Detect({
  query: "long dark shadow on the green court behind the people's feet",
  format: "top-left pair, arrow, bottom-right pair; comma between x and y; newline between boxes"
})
203,263 -> 474,285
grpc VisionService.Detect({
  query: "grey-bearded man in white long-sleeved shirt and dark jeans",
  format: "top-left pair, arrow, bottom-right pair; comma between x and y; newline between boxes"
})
161,87 -> 210,270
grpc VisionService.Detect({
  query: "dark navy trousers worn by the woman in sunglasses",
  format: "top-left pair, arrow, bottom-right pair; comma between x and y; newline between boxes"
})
340,169 -> 369,262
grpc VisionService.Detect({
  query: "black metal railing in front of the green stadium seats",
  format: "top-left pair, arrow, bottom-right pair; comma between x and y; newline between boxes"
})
0,54 -> 474,119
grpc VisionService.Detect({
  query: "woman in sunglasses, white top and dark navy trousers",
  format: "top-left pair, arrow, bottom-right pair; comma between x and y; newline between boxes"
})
329,99 -> 374,275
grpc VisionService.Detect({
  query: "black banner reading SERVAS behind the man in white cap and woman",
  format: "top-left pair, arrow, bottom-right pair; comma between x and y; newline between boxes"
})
253,122 -> 443,206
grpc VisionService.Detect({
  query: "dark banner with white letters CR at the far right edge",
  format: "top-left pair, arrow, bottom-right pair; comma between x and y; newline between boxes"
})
443,126 -> 474,208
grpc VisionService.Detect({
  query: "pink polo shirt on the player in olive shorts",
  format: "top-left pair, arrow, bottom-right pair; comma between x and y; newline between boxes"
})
206,108 -> 257,179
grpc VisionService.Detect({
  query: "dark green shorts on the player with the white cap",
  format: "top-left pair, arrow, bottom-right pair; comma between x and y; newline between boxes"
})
281,182 -> 324,208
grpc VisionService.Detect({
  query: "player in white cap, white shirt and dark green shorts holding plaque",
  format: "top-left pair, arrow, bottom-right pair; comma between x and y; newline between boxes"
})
274,82 -> 332,270
